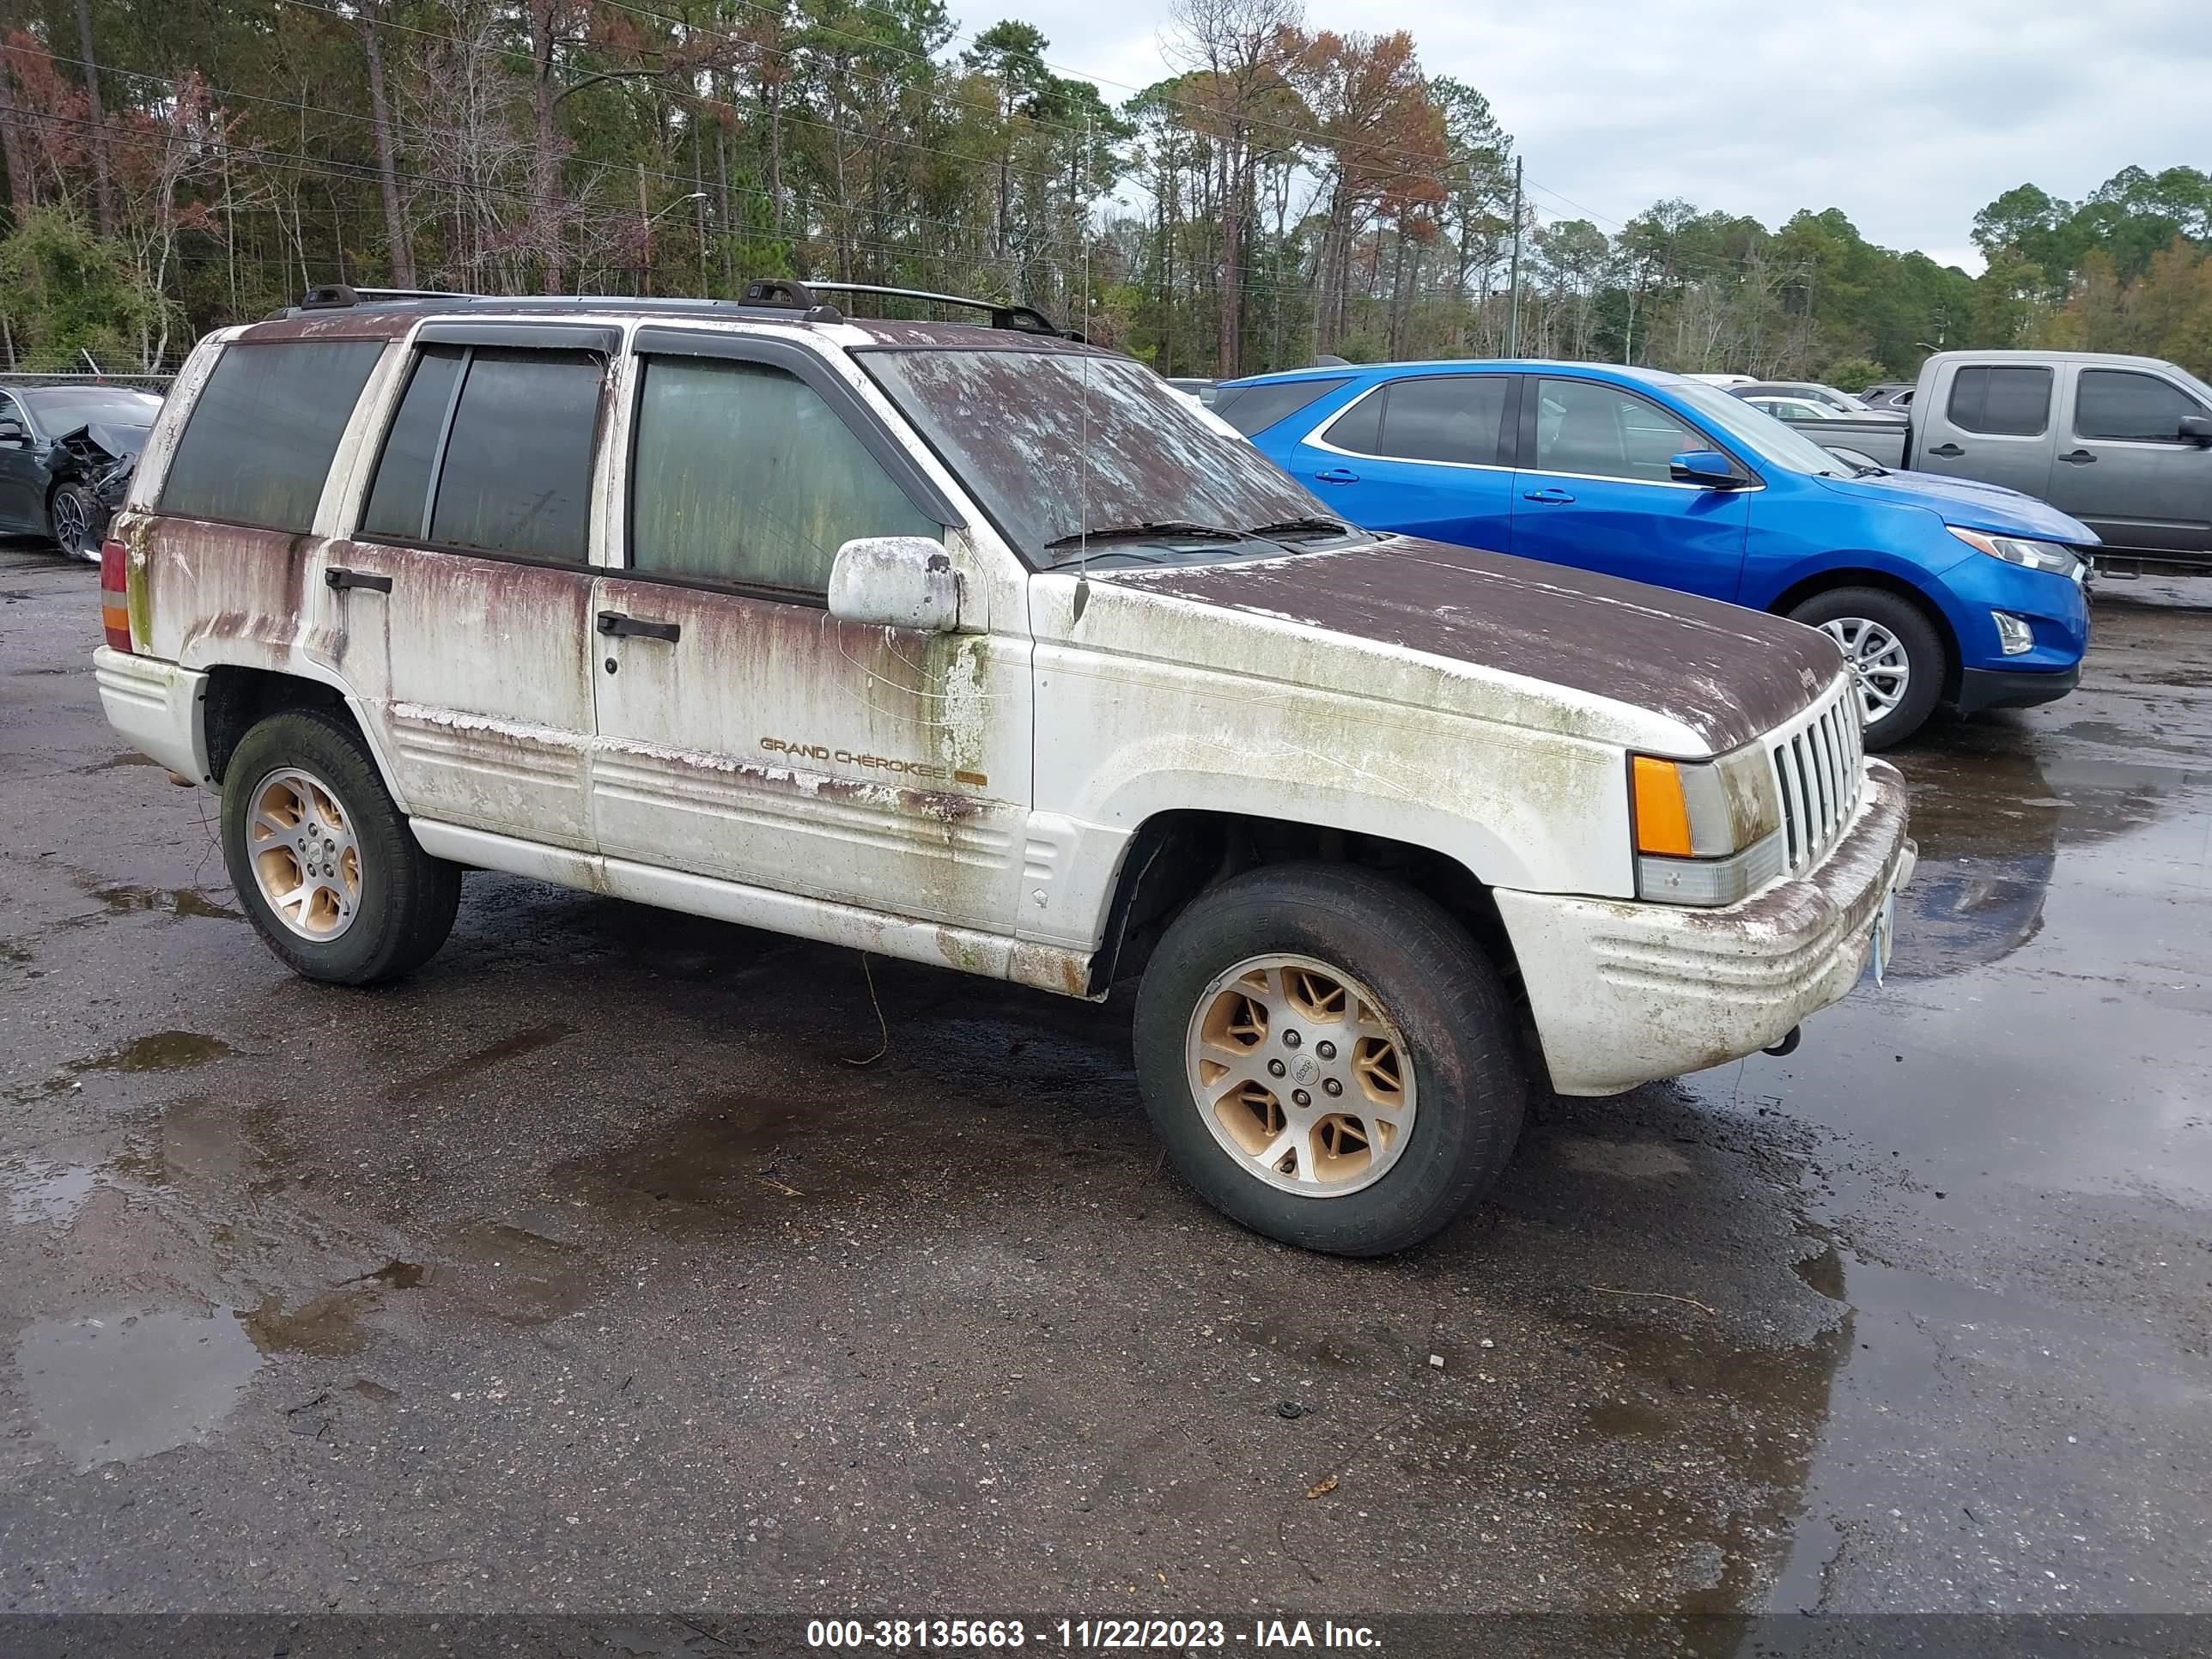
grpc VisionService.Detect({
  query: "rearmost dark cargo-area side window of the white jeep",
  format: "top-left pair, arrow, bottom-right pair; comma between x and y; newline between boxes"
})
161,341 -> 385,531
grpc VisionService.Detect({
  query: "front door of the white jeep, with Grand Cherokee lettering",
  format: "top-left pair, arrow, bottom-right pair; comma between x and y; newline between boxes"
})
591,327 -> 1030,933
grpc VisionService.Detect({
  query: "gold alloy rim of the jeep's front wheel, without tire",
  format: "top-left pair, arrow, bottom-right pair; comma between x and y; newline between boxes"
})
1183,956 -> 1413,1199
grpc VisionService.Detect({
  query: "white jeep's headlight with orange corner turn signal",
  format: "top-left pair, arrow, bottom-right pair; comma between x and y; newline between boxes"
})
1628,744 -> 1785,905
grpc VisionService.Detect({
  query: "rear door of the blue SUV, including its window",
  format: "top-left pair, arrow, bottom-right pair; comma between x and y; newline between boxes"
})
1291,374 -> 1517,553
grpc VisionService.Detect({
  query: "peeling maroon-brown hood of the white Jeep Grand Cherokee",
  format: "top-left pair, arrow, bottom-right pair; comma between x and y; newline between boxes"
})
1091,535 -> 1843,754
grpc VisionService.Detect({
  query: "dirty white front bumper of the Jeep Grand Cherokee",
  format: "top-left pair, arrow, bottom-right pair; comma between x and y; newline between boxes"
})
1495,761 -> 1917,1095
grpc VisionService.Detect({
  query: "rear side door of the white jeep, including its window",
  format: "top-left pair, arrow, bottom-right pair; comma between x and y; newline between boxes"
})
323,323 -> 619,849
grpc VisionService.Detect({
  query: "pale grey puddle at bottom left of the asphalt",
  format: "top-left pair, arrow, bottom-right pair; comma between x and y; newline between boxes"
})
15,1307 -> 261,1468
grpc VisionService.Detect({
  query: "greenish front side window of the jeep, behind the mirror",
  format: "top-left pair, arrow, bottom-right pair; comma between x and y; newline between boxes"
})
630,356 -> 945,595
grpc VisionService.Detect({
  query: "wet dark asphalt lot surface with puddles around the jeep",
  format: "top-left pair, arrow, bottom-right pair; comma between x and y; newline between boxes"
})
0,544 -> 2212,1617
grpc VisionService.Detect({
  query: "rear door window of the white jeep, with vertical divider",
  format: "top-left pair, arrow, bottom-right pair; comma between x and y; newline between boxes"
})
361,345 -> 604,564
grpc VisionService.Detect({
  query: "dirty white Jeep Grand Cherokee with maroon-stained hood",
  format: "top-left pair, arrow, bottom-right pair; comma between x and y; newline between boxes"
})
97,283 -> 1913,1255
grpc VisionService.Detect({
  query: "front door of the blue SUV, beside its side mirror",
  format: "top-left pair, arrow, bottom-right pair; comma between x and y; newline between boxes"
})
1513,374 -> 1752,599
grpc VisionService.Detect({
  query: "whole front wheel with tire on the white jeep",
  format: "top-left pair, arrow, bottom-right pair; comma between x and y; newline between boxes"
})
1137,865 -> 1526,1256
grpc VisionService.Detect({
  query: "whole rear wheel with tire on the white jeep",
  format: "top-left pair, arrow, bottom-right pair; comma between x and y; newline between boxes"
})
223,708 -> 460,984
